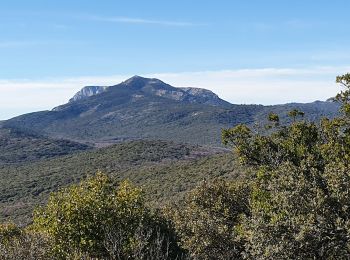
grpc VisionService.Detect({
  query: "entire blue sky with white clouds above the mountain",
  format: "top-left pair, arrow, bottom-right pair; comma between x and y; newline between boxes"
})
0,0 -> 350,120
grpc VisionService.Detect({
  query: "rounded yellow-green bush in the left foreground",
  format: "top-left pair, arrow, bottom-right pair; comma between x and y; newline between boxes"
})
31,173 -> 183,259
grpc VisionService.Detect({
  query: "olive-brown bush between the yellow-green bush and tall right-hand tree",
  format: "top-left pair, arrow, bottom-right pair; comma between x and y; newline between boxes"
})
167,180 -> 250,259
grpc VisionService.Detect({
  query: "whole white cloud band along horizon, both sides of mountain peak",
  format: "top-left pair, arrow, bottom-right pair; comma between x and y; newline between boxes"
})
0,67 -> 350,119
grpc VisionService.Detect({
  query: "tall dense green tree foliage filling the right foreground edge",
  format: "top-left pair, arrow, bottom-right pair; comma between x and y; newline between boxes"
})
223,74 -> 350,259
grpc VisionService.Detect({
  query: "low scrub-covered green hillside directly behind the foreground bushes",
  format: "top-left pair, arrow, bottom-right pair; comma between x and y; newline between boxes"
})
0,141 -> 239,224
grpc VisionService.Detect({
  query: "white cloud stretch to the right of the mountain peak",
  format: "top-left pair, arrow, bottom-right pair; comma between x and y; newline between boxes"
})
150,67 -> 348,105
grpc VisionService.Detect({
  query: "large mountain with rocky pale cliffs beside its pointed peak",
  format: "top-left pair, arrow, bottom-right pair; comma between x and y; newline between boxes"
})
2,76 -> 338,146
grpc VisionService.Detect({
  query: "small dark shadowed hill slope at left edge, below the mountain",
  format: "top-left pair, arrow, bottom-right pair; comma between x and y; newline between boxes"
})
0,128 -> 91,165
